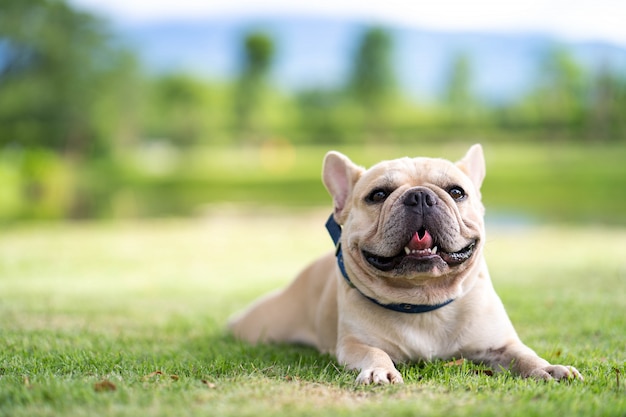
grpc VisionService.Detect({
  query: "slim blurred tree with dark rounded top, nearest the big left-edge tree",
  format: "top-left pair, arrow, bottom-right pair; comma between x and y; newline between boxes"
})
235,32 -> 274,140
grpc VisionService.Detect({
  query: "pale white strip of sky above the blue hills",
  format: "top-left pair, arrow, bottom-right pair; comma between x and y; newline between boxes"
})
69,0 -> 626,46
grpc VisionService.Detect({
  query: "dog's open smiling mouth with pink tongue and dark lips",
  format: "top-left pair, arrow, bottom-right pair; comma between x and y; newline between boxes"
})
362,228 -> 476,272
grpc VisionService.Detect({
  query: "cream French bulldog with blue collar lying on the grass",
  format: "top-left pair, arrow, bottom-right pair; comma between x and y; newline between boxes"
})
229,144 -> 583,384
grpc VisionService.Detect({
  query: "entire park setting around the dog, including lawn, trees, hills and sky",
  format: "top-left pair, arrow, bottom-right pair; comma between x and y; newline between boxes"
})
0,0 -> 626,417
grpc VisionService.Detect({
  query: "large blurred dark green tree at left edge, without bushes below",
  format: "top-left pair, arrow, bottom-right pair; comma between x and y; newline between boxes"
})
0,0 -> 136,155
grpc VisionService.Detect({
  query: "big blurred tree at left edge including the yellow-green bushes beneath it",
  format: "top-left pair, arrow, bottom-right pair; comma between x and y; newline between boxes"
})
0,0 -> 139,218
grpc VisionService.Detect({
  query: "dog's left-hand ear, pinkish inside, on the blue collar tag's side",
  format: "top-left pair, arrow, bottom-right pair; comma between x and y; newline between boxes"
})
322,151 -> 365,224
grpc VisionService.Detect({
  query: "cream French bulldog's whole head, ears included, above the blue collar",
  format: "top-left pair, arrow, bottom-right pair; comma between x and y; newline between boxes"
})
323,145 -> 485,302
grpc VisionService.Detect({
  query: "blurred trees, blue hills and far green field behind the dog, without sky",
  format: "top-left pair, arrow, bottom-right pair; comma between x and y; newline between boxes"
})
0,0 -> 626,224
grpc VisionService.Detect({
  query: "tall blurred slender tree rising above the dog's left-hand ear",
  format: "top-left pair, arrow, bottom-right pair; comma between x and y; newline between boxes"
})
348,28 -> 395,134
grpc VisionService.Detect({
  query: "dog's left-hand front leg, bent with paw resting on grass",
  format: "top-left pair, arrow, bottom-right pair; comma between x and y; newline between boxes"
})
337,336 -> 404,385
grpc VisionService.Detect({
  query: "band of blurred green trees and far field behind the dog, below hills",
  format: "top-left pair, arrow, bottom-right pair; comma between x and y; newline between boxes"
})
0,0 -> 626,223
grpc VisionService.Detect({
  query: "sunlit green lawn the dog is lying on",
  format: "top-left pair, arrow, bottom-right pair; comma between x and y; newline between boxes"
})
0,208 -> 626,417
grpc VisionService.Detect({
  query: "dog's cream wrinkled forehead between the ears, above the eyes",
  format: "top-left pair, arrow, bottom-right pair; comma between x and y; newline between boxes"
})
355,157 -> 470,193
